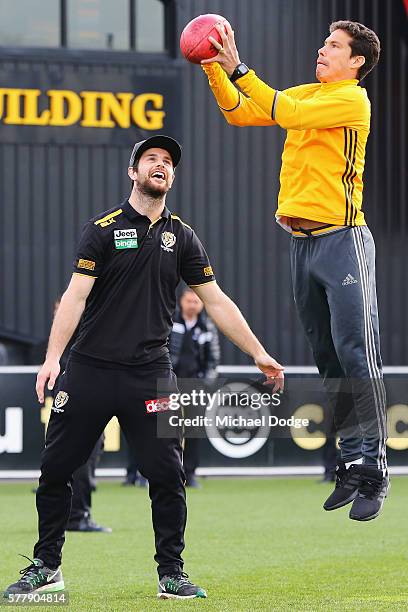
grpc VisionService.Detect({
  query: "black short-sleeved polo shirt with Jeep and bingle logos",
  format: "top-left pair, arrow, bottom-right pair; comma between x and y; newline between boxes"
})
72,201 -> 215,365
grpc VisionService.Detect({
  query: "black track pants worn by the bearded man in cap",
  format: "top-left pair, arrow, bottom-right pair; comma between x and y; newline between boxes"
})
34,358 -> 187,575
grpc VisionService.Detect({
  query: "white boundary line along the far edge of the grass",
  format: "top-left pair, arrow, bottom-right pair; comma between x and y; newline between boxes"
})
0,465 -> 408,481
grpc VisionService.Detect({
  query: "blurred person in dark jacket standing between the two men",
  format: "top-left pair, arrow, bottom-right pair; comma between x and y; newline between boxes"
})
169,287 -> 220,488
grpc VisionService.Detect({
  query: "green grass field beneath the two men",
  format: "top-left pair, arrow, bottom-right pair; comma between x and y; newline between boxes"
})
0,477 -> 408,612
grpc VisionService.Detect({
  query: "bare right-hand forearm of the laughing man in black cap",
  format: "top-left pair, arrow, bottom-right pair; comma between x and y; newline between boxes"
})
192,282 -> 284,391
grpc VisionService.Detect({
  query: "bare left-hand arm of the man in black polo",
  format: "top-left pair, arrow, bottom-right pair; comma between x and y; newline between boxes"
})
35,274 -> 95,404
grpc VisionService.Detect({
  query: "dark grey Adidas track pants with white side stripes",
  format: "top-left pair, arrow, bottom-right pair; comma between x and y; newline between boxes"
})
291,226 -> 387,473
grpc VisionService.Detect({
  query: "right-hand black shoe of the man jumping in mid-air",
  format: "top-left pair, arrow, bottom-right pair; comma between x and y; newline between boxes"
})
349,466 -> 390,521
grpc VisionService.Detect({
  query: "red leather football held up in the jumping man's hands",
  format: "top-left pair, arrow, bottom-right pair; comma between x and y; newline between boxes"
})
180,13 -> 228,64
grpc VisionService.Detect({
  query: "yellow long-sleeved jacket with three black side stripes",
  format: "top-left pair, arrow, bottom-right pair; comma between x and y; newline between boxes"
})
203,63 -> 370,226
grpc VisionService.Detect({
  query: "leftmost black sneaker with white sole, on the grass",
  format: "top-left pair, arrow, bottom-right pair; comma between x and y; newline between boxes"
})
4,555 -> 64,599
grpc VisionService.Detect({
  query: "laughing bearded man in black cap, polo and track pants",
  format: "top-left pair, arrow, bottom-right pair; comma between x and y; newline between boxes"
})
5,136 -> 283,599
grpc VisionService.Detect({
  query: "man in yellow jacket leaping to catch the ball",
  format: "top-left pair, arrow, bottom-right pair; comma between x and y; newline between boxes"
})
202,21 -> 389,521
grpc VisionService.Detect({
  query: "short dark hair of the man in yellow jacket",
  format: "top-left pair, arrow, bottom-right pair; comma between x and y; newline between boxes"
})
330,21 -> 381,81
